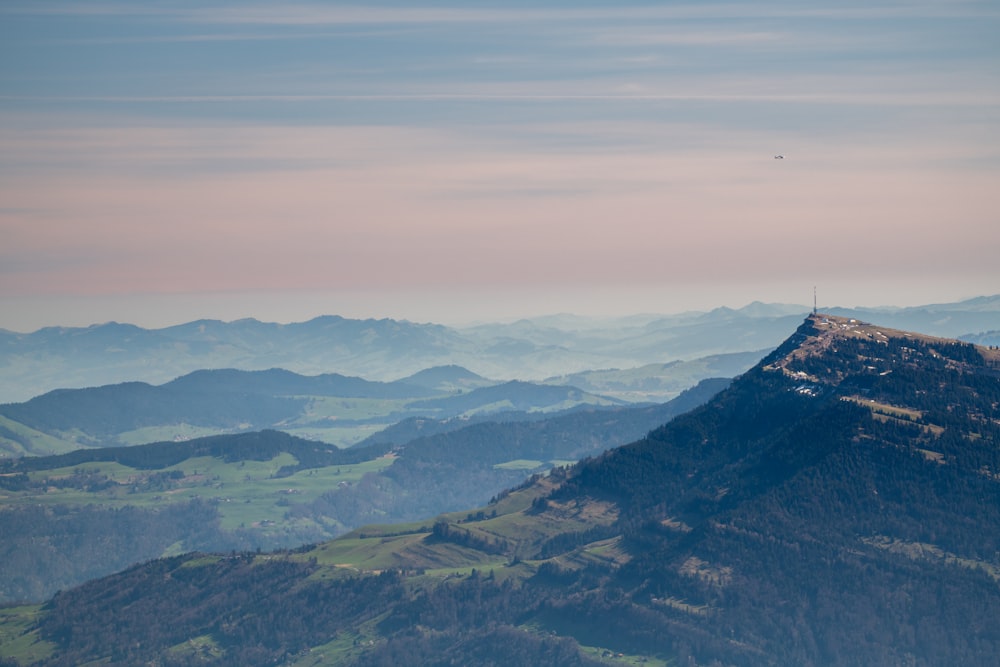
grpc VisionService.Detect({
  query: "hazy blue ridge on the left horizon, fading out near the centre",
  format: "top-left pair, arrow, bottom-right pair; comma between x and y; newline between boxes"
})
0,316 -> 468,401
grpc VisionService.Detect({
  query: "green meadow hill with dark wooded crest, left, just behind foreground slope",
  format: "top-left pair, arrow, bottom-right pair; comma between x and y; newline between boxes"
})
0,431 -> 393,603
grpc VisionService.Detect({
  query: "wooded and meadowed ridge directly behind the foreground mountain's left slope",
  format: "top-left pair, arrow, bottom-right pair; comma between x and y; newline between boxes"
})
0,380 -> 728,603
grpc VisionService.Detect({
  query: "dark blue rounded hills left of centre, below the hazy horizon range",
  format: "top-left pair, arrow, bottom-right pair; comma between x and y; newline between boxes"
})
0,367 -> 621,455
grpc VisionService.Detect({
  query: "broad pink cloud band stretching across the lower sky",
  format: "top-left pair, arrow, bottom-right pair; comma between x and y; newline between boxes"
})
0,127 -> 1000,306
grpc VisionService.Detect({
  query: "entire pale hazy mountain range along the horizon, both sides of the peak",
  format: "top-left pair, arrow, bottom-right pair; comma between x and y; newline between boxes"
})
0,296 -> 1000,402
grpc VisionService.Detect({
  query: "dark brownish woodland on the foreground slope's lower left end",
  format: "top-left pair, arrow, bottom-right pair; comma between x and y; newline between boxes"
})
39,553 -> 406,667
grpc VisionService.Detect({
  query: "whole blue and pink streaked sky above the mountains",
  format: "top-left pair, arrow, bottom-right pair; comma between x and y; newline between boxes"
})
0,0 -> 1000,332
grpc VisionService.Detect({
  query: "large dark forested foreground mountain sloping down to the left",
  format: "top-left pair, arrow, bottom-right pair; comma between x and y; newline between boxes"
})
0,315 -> 1000,667
